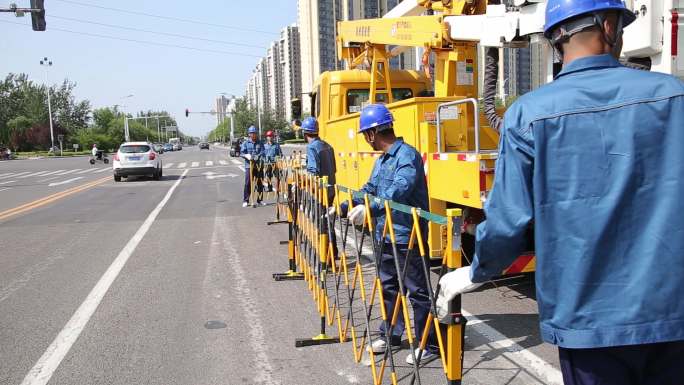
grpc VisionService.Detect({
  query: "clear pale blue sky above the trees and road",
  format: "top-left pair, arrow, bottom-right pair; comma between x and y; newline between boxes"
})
0,0 -> 297,136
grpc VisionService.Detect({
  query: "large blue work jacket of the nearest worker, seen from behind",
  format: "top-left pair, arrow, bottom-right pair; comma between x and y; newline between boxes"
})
471,55 -> 684,348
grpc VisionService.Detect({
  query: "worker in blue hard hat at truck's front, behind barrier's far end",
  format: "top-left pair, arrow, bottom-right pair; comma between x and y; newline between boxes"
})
301,117 -> 338,257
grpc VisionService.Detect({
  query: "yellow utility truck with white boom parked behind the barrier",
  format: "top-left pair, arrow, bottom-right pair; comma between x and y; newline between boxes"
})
298,0 -> 684,274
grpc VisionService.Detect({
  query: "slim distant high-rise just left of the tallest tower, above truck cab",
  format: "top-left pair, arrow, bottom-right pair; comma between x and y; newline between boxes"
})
280,24 -> 302,121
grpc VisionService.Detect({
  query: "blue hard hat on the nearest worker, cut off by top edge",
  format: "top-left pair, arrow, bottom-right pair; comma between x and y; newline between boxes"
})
544,0 -> 636,37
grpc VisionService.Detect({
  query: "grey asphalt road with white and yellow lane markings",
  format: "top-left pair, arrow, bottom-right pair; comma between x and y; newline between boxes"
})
0,147 -> 559,385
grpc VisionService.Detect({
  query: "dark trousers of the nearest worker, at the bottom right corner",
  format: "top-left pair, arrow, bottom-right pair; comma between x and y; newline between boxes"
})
558,341 -> 684,385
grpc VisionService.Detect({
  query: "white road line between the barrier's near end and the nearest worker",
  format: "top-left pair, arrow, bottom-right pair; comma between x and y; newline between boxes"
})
461,309 -> 563,385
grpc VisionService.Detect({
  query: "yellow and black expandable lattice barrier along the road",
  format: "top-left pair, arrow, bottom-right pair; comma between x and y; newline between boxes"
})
269,158 -> 466,385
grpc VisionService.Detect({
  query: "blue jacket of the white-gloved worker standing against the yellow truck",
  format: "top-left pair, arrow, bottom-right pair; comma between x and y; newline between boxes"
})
354,138 -> 428,245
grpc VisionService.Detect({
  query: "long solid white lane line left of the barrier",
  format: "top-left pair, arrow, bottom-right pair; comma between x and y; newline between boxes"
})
21,170 -> 188,385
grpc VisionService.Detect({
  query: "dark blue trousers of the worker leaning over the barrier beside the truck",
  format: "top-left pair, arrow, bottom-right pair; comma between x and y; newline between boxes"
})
378,243 -> 438,352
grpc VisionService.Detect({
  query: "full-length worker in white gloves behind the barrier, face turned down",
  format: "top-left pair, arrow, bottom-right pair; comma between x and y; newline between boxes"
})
342,104 -> 438,364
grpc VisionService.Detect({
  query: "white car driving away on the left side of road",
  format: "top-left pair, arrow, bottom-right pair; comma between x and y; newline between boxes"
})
112,142 -> 162,182
